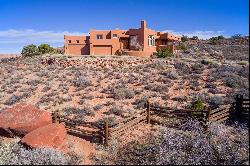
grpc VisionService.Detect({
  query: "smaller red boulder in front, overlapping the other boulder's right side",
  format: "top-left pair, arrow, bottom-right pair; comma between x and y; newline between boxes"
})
21,123 -> 67,148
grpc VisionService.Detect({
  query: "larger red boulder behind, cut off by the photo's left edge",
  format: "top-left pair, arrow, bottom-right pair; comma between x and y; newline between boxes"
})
0,103 -> 52,134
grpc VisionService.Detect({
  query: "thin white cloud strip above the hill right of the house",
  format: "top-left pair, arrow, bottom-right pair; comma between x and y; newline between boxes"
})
163,30 -> 227,39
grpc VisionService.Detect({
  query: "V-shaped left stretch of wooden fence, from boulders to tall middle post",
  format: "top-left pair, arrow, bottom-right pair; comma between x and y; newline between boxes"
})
52,112 -> 148,145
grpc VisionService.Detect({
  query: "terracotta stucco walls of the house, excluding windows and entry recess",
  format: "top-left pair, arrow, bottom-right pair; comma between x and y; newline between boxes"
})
64,20 -> 181,56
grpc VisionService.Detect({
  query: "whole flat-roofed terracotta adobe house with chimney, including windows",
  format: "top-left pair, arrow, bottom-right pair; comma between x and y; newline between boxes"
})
64,20 -> 181,57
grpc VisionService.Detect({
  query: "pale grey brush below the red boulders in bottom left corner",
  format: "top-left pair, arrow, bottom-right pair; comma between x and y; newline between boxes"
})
0,141 -> 80,165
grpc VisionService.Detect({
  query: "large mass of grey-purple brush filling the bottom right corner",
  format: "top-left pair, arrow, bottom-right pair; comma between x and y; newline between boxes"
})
109,121 -> 249,165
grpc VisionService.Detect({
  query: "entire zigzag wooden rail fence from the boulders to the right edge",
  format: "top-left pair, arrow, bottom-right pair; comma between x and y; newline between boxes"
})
53,96 -> 249,145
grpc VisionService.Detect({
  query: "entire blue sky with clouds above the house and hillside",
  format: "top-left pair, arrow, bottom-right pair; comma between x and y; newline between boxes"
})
0,0 -> 249,53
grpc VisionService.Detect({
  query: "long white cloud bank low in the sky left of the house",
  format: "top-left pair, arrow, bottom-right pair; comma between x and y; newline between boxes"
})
0,29 -> 87,44
